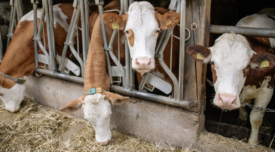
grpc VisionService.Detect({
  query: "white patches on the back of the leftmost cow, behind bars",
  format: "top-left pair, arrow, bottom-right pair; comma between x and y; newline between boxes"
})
18,4 -> 69,32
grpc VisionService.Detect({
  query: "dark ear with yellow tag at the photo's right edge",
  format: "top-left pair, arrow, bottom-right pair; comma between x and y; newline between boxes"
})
250,53 -> 275,69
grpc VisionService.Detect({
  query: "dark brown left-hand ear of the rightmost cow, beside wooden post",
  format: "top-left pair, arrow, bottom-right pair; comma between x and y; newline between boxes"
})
186,45 -> 211,62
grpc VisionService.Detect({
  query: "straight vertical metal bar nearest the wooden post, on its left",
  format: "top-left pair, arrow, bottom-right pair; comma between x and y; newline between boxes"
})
178,0 -> 186,100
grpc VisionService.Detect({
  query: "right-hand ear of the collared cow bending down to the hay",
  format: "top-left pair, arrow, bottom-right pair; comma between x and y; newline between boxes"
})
101,91 -> 129,105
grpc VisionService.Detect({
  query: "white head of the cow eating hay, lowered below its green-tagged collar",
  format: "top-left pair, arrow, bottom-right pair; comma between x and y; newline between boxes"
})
60,91 -> 129,145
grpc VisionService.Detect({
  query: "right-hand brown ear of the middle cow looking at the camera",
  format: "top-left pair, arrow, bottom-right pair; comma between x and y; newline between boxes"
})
155,12 -> 180,30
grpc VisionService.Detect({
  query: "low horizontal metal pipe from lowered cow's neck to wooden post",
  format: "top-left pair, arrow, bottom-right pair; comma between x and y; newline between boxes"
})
110,85 -> 195,109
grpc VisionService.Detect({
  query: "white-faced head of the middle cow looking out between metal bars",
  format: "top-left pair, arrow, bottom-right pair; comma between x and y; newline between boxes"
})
103,2 -> 180,73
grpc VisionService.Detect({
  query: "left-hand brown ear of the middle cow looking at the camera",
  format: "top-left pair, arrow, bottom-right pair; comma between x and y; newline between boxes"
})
102,13 -> 128,31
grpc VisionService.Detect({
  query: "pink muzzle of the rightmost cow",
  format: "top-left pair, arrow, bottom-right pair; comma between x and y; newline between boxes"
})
216,93 -> 239,110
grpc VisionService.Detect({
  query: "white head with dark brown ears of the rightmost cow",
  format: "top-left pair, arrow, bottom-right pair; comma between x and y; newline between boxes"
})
186,33 -> 275,110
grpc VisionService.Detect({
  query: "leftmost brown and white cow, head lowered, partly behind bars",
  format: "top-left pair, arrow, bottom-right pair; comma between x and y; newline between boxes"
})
0,4 -> 83,112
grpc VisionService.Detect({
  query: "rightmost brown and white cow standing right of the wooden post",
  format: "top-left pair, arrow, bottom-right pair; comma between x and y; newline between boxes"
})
186,14 -> 275,145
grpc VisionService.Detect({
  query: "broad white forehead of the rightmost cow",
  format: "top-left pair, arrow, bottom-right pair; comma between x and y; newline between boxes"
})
211,33 -> 254,69
